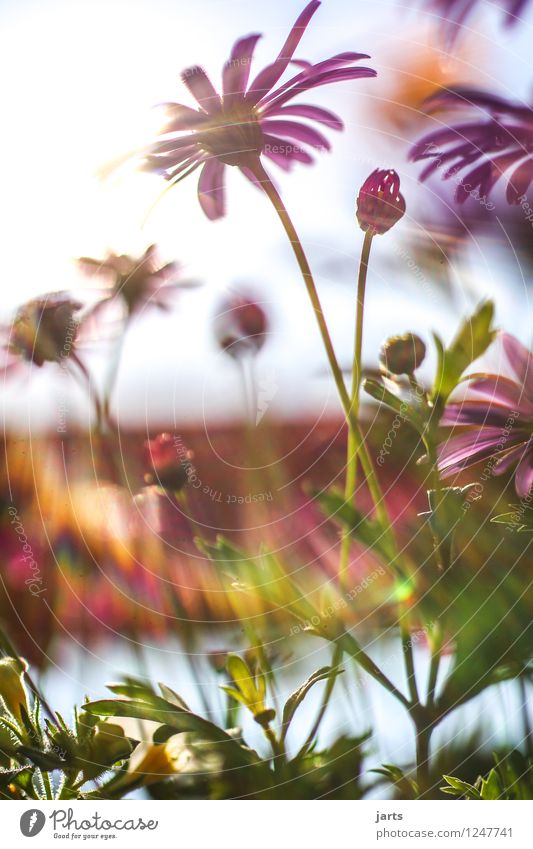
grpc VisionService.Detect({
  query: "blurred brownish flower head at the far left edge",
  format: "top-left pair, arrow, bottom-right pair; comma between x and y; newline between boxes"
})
2,293 -> 81,369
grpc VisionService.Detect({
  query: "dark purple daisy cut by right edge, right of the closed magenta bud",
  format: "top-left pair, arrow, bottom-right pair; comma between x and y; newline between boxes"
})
410,88 -> 533,204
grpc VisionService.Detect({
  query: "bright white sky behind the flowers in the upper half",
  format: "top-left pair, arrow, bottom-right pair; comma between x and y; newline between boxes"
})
0,0 -> 533,421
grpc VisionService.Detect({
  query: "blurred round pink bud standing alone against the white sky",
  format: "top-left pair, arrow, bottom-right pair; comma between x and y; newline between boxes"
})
215,295 -> 268,357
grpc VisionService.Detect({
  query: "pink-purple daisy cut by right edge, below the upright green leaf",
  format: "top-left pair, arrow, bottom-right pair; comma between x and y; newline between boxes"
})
439,334 -> 533,498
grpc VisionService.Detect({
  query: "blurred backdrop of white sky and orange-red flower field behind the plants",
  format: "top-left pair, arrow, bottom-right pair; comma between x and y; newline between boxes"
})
0,0 -> 533,796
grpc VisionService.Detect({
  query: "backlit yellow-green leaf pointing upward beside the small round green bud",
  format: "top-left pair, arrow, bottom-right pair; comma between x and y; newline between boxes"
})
432,301 -> 496,406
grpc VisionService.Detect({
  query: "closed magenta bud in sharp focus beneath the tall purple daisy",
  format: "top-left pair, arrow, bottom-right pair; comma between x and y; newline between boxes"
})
357,168 -> 405,235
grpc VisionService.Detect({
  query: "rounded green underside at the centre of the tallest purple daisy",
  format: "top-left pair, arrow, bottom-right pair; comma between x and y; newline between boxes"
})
198,106 -> 263,165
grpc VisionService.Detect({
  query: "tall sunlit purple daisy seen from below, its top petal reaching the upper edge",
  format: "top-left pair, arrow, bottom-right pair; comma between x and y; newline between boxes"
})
136,0 -> 376,220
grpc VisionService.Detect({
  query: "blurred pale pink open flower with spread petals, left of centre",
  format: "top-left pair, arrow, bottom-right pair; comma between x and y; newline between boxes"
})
78,245 -> 184,316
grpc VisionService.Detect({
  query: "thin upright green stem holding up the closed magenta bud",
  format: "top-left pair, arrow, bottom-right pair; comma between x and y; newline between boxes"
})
339,230 -> 373,589
